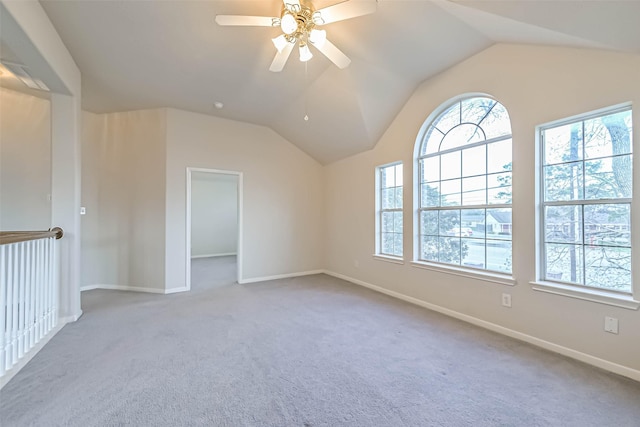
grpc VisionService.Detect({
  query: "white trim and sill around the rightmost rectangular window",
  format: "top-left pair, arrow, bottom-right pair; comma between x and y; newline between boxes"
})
529,102 -> 640,310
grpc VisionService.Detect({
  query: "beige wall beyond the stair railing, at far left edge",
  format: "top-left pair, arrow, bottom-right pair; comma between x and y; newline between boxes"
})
0,88 -> 51,231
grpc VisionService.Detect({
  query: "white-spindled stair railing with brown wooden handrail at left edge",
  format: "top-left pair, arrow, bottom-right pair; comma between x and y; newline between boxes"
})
0,228 -> 63,377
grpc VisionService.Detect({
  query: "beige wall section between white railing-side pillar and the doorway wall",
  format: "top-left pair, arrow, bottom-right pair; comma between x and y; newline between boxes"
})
81,109 -> 166,291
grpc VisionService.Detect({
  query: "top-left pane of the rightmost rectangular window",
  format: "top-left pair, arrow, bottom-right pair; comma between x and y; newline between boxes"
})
543,122 -> 582,164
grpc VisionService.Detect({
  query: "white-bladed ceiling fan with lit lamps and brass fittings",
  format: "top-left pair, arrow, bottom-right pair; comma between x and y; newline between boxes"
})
216,0 -> 376,72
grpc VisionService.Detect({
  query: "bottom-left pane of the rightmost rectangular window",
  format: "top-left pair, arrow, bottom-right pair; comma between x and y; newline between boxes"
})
544,243 -> 584,284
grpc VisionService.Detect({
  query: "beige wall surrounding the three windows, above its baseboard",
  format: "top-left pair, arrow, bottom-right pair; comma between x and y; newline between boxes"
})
325,45 -> 640,370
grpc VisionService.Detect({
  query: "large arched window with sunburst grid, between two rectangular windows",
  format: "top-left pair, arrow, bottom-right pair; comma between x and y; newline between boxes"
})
417,97 -> 512,273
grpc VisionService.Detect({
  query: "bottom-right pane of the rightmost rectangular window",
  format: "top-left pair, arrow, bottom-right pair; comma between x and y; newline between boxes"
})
585,246 -> 631,292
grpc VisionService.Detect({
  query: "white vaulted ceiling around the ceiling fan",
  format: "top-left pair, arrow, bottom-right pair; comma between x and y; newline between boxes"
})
33,0 -> 640,163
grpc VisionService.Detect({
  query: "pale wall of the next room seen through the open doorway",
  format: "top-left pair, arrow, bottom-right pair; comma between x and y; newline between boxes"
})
191,172 -> 238,258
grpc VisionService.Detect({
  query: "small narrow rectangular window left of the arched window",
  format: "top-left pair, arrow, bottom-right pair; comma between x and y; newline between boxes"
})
376,163 -> 403,257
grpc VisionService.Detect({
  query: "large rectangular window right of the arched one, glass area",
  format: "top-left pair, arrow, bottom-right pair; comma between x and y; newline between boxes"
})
540,107 -> 633,293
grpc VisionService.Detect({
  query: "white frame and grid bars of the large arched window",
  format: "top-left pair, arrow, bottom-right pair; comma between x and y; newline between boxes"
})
413,94 -> 514,284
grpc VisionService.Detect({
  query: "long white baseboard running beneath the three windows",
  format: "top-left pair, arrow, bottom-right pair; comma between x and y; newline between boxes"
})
324,270 -> 640,381
